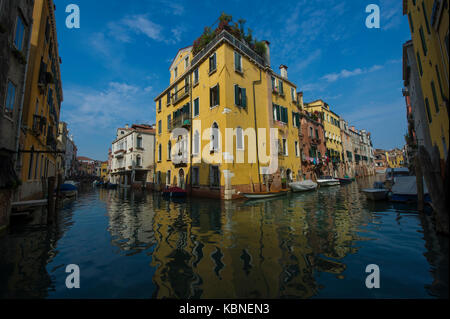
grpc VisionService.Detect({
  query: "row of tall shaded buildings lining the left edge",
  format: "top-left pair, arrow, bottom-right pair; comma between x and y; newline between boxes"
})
0,0 -> 77,228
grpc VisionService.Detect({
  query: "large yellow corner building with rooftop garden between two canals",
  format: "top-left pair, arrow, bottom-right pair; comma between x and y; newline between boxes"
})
155,16 -> 301,199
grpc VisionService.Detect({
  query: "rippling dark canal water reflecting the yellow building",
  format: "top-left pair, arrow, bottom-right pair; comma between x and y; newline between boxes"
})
0,178 -> 448,298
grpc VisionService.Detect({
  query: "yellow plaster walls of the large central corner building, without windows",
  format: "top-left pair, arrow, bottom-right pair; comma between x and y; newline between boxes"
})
155,37 -> 301,198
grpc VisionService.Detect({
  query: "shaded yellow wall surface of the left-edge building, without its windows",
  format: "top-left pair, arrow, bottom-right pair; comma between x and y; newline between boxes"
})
21,0 -> 62,200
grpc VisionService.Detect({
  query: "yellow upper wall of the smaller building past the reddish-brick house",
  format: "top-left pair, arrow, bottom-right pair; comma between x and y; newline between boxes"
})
305,100 -> 342,161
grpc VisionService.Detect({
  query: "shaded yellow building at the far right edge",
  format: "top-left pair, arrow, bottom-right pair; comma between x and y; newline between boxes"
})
403,0 -> 450,164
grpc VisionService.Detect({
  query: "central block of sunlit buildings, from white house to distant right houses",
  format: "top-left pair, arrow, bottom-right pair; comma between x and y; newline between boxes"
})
102,16 -> 375,199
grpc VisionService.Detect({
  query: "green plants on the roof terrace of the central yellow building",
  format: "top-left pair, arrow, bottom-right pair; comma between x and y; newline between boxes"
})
192,12 -> 266,56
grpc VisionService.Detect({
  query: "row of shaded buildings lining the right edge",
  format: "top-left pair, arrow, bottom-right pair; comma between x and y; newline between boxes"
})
403,0 -> 450,171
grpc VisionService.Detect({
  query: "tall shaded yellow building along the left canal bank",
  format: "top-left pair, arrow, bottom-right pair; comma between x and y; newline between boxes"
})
19,0 -> 63,199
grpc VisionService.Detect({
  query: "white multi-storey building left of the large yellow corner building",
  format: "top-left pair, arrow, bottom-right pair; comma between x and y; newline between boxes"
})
110,124 -> 155,187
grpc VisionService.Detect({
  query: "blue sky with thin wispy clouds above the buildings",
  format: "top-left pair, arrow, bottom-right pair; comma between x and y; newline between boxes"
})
55,0 -> 410,160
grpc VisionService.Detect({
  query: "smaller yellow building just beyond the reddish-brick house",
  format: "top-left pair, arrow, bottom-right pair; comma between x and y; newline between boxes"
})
304,100 -> 342,168
